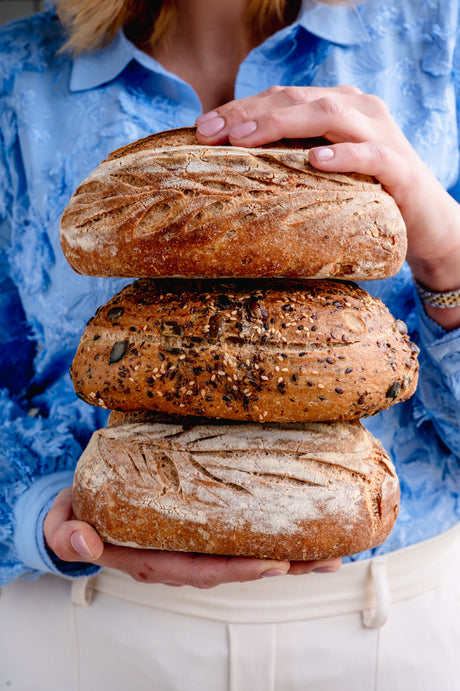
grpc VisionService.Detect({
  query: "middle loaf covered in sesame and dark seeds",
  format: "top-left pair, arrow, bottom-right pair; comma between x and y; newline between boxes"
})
71,279 -> 418,422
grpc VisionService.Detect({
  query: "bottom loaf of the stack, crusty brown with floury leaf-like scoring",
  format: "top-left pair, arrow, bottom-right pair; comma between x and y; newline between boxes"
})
73,421 -> 399,560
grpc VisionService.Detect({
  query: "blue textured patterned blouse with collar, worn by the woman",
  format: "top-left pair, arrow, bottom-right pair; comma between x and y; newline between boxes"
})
0,0 -> 460,583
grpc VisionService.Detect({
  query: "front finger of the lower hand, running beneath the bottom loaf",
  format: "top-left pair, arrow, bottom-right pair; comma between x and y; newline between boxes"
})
98,545 -> 289,588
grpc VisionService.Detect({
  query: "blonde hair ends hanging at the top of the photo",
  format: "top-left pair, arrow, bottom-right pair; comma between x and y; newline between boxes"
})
56,0 -> 343,54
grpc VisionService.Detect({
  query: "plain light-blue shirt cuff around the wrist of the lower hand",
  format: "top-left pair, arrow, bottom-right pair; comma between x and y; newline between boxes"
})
14,470 -> 99,577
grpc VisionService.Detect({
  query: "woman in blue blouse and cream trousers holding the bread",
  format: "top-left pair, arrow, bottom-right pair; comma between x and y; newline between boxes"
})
0,0 -> 460,691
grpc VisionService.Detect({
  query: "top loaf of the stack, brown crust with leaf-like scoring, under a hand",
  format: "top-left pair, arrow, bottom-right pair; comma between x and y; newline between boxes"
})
61,128 -> 406,280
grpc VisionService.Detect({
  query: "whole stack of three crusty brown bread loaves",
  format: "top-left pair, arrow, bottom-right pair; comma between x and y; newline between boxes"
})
61,128 -> 418,560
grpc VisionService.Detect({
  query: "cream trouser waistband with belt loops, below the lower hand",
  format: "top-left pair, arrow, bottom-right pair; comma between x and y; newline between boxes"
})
72,526 -> 460,627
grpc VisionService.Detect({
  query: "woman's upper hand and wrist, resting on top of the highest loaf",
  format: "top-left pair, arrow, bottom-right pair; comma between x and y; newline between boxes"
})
197,86 -> 460,330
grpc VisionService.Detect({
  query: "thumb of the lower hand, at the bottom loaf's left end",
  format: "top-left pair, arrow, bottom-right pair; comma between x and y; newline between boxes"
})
43,487 -> 104,562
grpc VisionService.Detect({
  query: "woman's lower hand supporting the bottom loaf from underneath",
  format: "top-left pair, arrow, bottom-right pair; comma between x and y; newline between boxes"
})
44,487 -> 341,588
